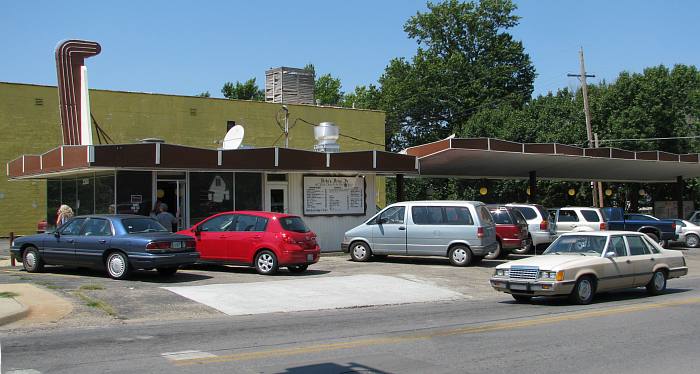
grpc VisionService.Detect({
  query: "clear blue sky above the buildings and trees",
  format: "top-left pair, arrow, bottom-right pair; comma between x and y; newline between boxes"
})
0,0 -> 700,97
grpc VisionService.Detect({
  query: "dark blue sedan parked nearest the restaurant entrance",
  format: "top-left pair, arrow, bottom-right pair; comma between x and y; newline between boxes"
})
10,214 -> 199,279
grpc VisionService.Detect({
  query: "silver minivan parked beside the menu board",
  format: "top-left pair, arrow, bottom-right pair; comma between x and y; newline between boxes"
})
341,200 -> 496,266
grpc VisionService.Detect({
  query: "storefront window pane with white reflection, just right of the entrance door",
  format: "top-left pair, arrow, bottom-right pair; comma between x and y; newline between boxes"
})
190,172 -> 234,224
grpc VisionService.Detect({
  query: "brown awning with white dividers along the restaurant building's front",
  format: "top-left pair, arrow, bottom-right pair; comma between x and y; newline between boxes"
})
7,143 -> 418,179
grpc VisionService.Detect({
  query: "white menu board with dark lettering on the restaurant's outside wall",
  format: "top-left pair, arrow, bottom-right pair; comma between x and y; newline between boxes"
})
304,176 -> 365,215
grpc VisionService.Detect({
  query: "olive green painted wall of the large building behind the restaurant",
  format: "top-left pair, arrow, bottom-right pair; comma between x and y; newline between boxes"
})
0,82 -> 385,236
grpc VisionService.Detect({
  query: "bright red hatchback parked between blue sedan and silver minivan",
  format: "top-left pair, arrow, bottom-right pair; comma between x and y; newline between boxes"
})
178,211 -> 321,274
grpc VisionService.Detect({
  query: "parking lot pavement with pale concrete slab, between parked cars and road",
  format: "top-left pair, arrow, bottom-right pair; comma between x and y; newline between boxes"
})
0,241 -> 700,332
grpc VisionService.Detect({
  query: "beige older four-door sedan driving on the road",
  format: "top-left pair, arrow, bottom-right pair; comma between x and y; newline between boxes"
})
490,231 -> 688,304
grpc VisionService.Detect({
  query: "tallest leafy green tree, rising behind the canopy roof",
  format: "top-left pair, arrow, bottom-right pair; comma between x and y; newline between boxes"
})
379,0 -> 535,150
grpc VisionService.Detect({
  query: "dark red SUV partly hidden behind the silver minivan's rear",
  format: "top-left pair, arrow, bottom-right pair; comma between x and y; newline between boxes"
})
485,205 -> 528,259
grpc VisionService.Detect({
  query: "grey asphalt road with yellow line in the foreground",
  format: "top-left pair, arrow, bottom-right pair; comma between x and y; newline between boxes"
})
0,275 -> 700,374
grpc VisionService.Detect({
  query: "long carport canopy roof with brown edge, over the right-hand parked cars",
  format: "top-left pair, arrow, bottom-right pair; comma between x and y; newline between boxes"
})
405,138 -> 700,182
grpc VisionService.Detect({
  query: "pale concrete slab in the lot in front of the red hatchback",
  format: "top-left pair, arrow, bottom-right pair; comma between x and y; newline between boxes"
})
163,274 -> 464,315
